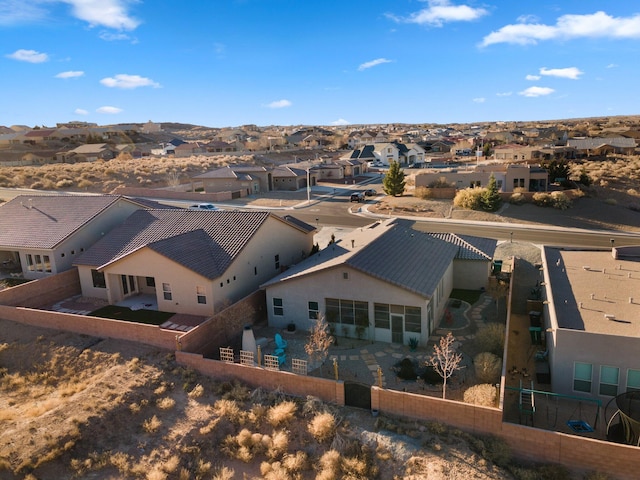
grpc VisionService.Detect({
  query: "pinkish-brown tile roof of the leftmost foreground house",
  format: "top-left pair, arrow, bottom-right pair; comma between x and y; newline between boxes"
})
0,195 -> 135,249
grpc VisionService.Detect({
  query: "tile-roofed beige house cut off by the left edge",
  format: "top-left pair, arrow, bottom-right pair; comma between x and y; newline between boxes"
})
0,195 -> 151,279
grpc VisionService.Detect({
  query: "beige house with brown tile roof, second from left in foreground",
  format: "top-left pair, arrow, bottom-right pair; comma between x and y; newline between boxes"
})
75,210 -> 315,315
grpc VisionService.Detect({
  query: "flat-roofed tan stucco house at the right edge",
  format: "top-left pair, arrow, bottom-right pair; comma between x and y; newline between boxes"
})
532,248 -> 640,403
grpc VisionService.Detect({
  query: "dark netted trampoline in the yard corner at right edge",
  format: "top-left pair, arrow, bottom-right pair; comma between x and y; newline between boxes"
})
605,391 -> 640,447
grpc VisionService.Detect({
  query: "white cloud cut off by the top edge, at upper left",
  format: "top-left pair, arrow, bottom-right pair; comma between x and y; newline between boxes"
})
62,0 -> 140,30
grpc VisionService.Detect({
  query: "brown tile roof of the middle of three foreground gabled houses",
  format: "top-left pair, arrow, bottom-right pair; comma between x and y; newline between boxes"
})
75,210 -> 271,279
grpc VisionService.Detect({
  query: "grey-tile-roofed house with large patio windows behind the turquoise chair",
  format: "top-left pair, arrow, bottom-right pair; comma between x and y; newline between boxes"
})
262,219 -> 496,345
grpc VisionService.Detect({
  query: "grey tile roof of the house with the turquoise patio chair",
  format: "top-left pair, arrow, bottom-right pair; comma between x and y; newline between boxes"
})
261,219 -> 496,296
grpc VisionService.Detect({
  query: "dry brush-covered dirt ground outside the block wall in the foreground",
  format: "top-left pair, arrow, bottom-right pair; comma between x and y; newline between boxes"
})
0,320 -> 524,480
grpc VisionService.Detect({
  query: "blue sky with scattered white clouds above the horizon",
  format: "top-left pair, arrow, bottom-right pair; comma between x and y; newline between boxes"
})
0,0 -> 640,127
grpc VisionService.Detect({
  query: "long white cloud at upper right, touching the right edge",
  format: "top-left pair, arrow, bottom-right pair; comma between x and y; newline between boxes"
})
480,11 -> 640,47
